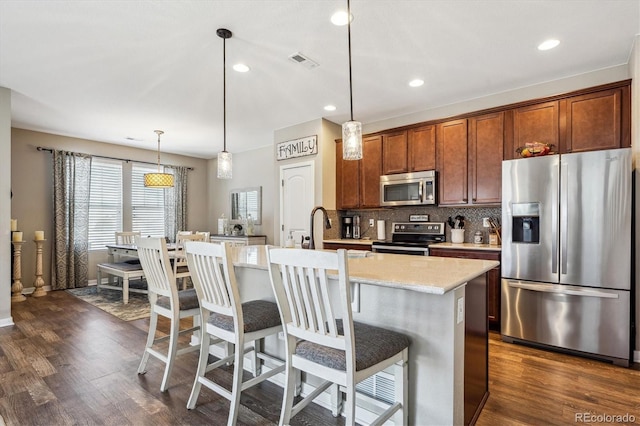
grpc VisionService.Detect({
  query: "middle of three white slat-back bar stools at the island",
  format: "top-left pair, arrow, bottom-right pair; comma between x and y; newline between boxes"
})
185,242 -> 284,426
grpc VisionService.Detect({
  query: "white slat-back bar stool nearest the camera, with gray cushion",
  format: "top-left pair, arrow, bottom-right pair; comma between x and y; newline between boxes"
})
265,246 -> 410,425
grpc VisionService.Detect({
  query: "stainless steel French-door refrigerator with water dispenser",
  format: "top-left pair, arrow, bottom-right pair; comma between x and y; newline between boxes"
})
501,148 -> 632,366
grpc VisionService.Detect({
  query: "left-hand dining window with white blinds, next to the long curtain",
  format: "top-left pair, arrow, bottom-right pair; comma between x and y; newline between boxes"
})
89,158 -> 122,250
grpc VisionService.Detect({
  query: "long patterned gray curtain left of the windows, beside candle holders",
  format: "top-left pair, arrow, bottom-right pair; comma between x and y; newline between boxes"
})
51,150 -> 91,290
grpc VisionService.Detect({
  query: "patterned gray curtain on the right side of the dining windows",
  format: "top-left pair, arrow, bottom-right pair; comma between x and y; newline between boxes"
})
164,166 -> 189,242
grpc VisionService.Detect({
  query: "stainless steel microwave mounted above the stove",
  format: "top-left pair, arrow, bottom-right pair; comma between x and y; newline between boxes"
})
380,170 -> 436,206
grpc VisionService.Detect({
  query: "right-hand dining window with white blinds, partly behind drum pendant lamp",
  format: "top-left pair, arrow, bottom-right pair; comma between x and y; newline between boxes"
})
131,164 -> 165,237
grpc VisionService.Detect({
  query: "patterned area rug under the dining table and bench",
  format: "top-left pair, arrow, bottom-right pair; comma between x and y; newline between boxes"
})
67,286 -> 149,321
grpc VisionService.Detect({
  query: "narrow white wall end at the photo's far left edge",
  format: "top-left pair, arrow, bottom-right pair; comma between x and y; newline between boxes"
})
0,87 -> 13,327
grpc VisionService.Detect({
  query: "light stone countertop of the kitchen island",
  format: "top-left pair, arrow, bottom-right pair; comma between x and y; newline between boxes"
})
233,246 -> 500,294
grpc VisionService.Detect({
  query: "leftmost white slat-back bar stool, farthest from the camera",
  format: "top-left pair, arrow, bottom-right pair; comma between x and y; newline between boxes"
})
136,238 -> 200,392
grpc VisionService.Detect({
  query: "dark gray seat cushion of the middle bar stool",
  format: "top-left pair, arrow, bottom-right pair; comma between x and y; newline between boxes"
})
207,300 -> 281,333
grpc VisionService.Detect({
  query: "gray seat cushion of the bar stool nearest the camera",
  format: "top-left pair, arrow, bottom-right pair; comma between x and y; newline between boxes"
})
296,320 -> 411,371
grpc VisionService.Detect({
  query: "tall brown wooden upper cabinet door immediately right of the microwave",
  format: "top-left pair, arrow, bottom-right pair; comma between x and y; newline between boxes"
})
436,119 -> 468,206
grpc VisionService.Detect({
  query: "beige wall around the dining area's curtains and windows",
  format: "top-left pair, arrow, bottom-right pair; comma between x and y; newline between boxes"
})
10,128 -> 208,289
